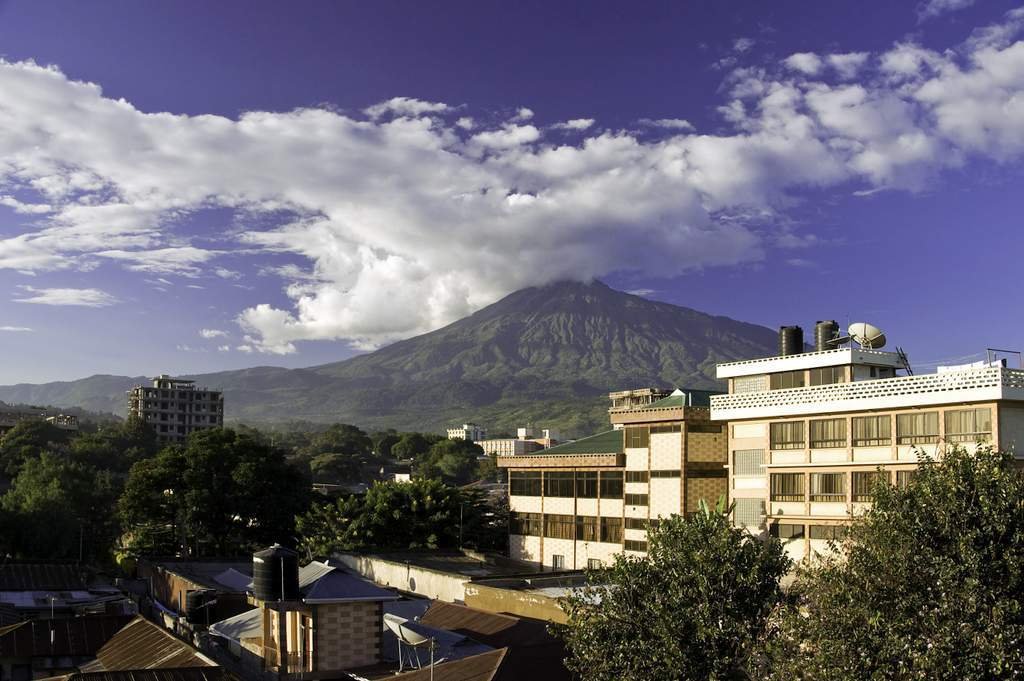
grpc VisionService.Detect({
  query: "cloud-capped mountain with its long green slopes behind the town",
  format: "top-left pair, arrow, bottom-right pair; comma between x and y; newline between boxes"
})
0,282 -> 776,435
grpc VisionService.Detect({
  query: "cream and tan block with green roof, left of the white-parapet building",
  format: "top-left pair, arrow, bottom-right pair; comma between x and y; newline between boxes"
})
498,390 -> 728,569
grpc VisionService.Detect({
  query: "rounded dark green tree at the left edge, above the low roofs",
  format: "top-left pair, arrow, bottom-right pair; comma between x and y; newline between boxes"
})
2,452 -> 117,561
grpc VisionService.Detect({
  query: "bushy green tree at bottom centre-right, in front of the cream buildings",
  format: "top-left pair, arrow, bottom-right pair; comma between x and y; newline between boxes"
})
554,506 -> 790,681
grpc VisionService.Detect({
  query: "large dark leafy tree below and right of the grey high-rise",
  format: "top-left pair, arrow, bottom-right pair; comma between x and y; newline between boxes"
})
120,429 -> 309,555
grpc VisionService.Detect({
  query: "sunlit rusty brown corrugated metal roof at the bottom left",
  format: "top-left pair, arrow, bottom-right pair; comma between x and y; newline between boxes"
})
82,615 -> 215,672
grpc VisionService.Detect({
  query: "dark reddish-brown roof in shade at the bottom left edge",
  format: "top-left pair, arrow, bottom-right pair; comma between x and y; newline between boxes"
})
0,614 -> 132,657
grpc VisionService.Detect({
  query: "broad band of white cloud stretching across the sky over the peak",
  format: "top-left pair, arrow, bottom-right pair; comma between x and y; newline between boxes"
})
0,15 -> 1024,353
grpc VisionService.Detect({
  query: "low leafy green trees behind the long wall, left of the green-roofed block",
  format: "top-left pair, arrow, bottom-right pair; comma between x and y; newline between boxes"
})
297,479 -> 508,556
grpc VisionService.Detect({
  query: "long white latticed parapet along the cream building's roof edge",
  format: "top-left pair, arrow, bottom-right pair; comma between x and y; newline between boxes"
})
711,367 -> 1024,420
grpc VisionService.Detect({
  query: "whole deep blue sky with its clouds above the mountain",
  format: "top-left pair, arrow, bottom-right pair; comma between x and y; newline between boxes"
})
0,0 -> 1024,383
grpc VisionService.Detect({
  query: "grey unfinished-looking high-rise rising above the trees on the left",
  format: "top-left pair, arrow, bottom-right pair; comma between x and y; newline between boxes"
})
128,374 -> 224,442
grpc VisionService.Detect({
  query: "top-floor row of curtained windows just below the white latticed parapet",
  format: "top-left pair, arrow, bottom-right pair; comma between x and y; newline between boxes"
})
770,407 -> 992,450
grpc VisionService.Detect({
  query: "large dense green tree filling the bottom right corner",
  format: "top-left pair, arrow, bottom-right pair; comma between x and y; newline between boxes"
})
765,449 -> 1024,681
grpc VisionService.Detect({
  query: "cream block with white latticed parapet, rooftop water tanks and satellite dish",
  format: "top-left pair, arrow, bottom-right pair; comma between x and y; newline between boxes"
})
711,323 -> 1024,560
